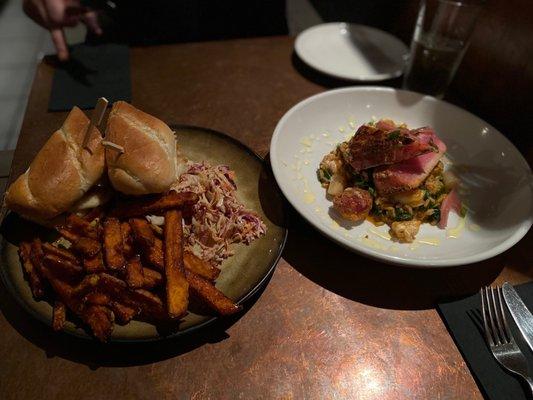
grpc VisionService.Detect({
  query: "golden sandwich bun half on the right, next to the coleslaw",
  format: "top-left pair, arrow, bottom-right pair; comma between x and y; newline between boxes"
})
106,101 -> 177,195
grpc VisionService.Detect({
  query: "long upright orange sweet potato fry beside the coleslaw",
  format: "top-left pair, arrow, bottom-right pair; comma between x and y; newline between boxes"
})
164,210 -> 189,318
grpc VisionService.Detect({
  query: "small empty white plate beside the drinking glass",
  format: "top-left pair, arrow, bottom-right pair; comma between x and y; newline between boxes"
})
294,22 -> 408,82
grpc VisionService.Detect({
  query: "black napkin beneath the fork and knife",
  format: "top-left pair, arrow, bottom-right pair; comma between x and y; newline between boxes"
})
438,283 -> 533,400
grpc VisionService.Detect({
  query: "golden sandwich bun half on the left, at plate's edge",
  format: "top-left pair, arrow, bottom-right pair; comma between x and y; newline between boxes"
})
5,107 -> 105,223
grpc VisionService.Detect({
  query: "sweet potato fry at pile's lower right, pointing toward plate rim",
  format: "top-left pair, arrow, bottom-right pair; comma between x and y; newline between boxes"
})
185,271 -> 241,315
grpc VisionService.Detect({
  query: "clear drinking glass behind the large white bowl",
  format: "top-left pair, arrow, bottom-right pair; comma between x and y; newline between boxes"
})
403,0 -> 483,98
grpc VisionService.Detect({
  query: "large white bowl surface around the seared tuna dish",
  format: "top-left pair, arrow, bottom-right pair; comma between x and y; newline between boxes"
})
270,87 -> 533,267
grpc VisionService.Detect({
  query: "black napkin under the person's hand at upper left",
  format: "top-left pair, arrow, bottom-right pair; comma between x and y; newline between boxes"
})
48,44 -> 131,111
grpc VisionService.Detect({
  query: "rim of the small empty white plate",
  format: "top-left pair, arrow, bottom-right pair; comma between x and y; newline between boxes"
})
294,21 -> 409,82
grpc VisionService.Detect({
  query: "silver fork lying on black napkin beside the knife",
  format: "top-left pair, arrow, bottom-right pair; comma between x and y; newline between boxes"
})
481,287 -> 533,394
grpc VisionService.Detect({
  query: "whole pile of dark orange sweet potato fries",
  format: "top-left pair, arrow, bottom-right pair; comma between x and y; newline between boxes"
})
19,192 -> 240,341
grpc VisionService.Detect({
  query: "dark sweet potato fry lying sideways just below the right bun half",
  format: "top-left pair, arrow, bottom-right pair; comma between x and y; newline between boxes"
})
110,191 -> 198,219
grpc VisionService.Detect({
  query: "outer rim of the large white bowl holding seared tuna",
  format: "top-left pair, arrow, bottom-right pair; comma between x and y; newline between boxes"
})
270,86 -> 533,268
